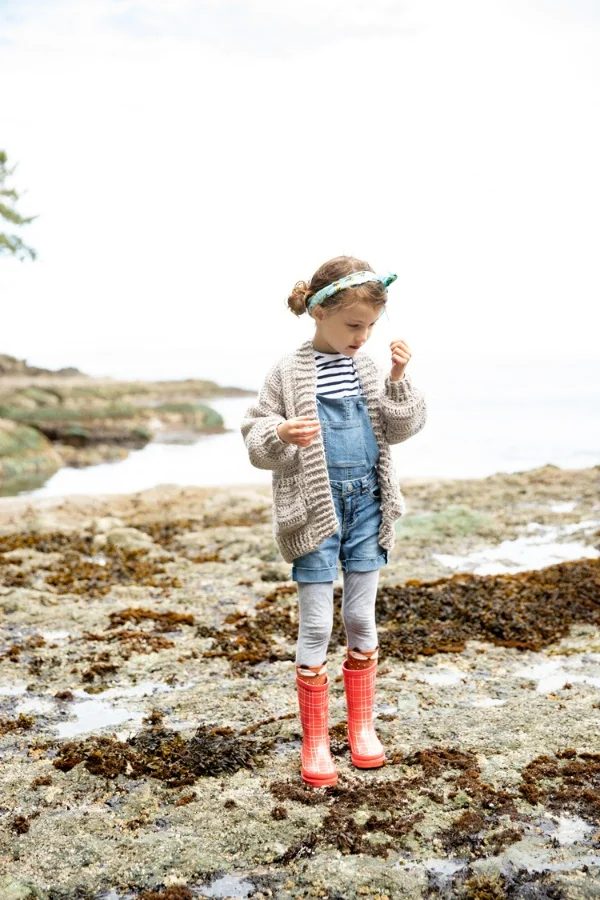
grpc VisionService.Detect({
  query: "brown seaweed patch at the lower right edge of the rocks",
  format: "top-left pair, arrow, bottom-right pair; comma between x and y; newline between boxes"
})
519,747 -> 600,825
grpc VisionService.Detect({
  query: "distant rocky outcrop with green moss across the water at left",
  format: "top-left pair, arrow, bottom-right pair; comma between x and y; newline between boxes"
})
0,354 -> 254,494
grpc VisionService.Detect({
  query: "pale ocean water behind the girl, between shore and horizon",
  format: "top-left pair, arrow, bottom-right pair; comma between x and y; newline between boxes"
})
15,359 -> 600,496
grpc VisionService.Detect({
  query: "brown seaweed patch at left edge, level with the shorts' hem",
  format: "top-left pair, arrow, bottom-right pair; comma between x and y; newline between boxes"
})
0,532 -> 181,597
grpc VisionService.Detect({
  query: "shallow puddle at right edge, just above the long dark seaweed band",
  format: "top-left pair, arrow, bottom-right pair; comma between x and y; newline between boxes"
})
432,519 -> 600,575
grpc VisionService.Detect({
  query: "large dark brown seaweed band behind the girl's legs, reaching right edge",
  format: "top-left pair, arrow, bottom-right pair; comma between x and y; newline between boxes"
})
202,559 -> 600,675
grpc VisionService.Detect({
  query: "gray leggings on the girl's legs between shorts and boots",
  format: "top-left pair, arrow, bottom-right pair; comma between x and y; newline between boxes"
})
296,569 -> 379,666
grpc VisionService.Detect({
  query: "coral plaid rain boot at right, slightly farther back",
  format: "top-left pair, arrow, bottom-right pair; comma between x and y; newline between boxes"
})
342,650 -> 385,769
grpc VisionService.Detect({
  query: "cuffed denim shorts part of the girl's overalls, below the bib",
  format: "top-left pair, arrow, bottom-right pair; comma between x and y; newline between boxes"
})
291,467 -> 388,581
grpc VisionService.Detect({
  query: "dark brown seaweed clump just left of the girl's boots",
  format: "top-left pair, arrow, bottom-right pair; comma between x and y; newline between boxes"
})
52,724 -> 273,787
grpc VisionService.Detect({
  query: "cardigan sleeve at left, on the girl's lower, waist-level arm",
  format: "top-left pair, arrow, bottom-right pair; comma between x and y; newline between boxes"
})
240,363 -> 300,469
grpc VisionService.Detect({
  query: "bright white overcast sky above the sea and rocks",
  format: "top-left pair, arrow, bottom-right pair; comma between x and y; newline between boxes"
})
0,0 -> 600,386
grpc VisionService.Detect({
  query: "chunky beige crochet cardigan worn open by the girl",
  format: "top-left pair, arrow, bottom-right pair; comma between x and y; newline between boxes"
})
240,338 -> 427,562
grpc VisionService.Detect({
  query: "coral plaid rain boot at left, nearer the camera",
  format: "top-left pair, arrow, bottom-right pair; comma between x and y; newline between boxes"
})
296,667 -> 338,787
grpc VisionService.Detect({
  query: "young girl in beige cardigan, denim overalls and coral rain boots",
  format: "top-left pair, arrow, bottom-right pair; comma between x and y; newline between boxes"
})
241,256 -> 427,787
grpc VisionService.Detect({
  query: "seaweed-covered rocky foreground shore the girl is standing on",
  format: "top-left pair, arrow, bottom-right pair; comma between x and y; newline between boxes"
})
0,468 -> 600,900
